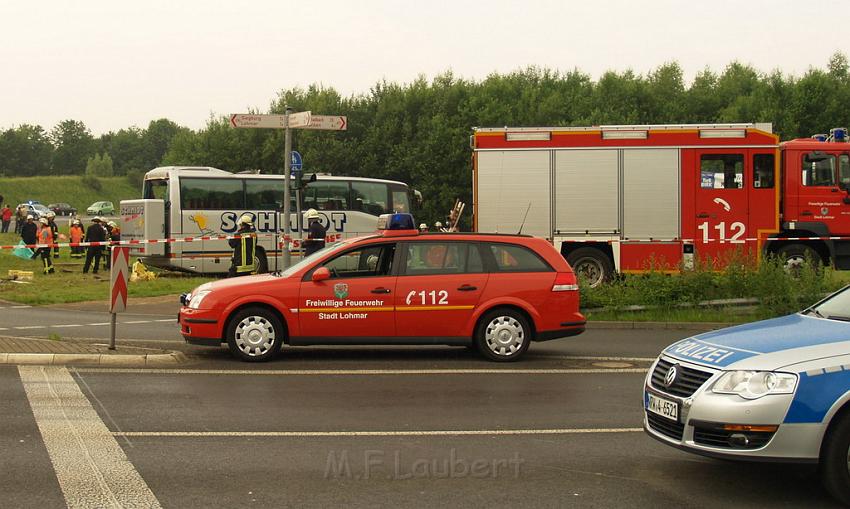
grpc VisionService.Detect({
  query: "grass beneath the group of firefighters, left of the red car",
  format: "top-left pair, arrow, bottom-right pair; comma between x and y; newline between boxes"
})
0,233 -> 215,305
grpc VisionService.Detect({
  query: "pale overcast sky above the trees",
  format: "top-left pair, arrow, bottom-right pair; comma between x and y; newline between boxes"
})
0,0 -> 850,136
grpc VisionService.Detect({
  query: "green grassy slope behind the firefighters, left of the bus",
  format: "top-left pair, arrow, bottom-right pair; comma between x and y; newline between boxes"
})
0,176 -> 142,213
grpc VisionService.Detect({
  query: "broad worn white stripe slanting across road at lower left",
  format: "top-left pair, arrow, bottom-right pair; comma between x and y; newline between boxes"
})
18,366 -> 161,509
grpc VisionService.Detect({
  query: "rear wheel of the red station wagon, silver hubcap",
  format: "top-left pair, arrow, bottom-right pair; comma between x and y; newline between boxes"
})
475,308 -> 532,362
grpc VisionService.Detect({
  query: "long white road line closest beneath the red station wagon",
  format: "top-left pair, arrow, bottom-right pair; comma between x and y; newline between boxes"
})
77,368 -> 646,376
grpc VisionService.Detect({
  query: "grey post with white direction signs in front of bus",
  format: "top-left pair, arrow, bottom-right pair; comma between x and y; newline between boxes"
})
230,106 -> 348,268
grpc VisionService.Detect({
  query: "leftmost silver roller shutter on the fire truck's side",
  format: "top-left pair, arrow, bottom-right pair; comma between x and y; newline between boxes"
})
476,150 -> 552,237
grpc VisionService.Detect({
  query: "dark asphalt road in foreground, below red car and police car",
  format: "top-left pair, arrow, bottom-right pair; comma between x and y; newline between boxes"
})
0,324 -> 832,507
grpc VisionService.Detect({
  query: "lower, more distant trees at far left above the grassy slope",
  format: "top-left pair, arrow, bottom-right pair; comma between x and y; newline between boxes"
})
0,119 -> 188,177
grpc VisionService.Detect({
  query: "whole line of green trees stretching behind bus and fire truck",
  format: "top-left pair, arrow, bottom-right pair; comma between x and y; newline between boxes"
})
0,53 -> 850,221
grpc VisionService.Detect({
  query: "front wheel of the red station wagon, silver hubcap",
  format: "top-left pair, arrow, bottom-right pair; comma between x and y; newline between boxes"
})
227,307 -> 284,362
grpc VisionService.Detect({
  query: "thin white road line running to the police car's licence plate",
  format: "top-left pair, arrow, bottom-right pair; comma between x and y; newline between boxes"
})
112,428 -> 643,437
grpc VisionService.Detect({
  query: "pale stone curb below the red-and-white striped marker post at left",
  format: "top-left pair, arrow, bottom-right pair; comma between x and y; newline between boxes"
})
0,352 -> 187,367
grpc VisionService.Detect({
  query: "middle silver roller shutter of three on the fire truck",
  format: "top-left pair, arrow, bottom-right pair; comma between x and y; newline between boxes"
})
555,150 -> 620,234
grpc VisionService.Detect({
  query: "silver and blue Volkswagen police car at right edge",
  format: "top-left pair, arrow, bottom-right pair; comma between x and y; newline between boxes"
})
644,287 -> 850,504
